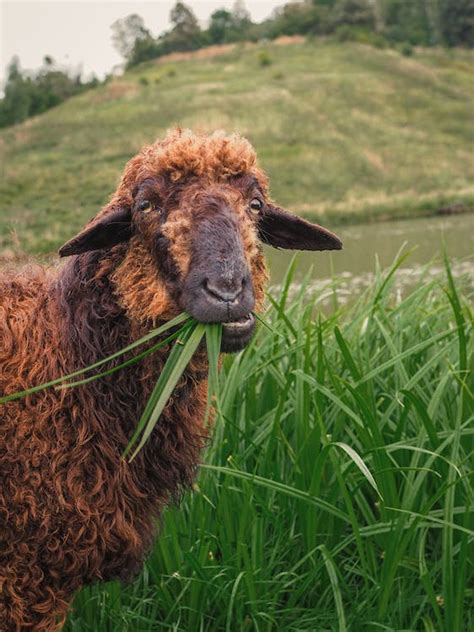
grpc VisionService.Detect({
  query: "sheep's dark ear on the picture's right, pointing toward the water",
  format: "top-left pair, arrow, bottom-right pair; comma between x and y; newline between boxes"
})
259,205 -> 342,250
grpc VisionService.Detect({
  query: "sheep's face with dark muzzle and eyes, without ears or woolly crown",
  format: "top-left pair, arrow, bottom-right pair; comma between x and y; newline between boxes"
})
132,174 -> 266,351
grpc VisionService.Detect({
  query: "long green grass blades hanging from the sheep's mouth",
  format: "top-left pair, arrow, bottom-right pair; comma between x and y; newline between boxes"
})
0,312 -> 222,461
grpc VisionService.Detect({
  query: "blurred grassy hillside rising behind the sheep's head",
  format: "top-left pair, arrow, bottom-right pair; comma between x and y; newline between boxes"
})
0,42 -> 474,257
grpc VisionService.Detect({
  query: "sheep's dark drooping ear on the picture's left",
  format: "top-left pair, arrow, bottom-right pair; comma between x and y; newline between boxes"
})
59,208 -> 132,257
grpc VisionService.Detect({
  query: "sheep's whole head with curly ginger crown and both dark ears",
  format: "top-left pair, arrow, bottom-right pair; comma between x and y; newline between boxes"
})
59,130 -> 341,351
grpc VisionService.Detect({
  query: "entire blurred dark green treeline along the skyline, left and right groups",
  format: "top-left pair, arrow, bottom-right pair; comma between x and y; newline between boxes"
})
0,0 -> 474,127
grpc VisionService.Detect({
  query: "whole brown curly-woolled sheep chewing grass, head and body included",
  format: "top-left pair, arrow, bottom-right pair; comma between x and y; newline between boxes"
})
0,130 -> 341,632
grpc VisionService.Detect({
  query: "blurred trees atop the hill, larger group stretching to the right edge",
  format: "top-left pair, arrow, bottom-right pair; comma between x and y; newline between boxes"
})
119,0 -> 474,67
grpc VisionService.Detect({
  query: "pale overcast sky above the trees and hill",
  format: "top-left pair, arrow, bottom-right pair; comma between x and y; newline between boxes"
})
0,0 -> 285,79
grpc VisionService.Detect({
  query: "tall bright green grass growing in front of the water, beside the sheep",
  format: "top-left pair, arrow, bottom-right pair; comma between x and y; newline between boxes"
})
65,258 -> 474,632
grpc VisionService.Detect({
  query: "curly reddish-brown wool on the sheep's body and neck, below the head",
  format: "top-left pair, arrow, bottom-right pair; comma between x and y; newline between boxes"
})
0,246 -> 206,632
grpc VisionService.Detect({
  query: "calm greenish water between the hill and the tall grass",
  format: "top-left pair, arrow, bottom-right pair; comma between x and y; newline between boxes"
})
266,213 -> 474,302
